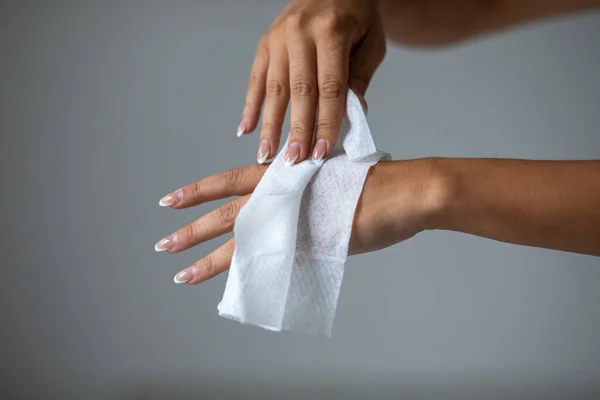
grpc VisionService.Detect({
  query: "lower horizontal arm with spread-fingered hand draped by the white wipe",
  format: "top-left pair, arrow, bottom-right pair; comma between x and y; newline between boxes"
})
155,158 -> 600,285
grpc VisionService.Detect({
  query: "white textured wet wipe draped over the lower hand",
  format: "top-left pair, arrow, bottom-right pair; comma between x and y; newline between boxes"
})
219,92 -> 388,337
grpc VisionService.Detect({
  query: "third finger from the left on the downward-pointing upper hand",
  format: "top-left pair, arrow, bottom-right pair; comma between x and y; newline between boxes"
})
285,30 -> 318,166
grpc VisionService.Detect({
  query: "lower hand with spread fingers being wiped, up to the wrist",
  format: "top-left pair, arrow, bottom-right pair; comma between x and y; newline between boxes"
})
155,160 -> 441,284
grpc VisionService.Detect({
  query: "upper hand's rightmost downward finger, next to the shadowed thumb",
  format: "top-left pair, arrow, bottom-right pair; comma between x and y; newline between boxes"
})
312,33 -> 350,161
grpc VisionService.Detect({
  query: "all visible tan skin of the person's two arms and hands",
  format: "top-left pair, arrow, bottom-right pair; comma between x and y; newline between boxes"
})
156,0 -> 600,284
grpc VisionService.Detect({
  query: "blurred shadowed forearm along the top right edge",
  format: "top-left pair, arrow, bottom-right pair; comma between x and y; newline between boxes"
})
379,0 -> 600,46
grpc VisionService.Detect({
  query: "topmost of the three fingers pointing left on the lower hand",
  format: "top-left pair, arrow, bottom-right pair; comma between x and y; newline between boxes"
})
159,164 -> 268,209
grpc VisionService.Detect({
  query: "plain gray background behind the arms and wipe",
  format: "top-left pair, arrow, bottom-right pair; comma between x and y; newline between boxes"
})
0,0 -> 600,399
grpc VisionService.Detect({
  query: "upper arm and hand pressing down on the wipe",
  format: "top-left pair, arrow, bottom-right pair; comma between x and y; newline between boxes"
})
238,0 -> 600,164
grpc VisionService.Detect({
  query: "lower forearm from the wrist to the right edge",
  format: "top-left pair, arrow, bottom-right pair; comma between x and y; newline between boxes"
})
428,158 -> 600,256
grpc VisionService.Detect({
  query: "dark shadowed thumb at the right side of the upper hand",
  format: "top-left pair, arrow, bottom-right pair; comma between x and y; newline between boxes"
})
348,23 -> 386,101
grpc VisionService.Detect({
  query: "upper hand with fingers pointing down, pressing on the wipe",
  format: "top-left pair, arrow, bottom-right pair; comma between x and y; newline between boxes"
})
238,0 -> 385,165
